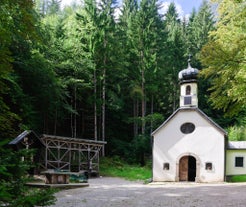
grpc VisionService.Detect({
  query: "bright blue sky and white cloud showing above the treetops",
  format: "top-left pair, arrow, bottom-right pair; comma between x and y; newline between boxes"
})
61,0 -> 203,16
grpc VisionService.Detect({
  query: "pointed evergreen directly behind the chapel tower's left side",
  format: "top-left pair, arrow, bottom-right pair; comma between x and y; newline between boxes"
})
164,3 -> 187,114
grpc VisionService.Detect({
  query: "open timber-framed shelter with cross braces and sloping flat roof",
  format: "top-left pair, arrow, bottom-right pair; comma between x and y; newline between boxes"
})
41,134 -> 106,174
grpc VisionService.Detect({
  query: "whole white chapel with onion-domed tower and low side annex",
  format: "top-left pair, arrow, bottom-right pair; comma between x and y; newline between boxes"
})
152,60 -> 246,182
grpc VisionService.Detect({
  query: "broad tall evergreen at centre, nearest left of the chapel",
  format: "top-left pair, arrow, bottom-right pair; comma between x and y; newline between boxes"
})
123,0 -> 163,164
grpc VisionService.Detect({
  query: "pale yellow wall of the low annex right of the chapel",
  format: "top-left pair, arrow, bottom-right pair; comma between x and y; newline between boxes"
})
226,149 -> 246,175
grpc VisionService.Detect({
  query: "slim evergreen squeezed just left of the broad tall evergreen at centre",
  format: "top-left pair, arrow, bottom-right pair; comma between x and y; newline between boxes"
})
118,0 -> 142,136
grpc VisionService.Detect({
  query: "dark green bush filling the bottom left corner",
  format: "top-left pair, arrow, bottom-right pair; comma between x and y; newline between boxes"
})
0,145 -> 56,207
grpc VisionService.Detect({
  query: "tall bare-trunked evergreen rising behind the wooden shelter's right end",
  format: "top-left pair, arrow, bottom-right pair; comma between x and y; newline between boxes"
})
78,1 -> 118,154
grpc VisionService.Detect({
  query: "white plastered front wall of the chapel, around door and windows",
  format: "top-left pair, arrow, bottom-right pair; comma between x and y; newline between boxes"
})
153,110 -> 224,182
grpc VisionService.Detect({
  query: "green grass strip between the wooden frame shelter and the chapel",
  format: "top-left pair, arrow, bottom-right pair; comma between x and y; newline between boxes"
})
100,157 -> 152,181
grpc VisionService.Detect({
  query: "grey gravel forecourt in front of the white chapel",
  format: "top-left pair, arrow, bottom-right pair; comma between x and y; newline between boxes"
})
49,177 -> 246,207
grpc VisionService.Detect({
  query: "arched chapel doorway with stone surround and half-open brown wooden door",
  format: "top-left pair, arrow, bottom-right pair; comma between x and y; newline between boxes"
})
176,153 -> 200,182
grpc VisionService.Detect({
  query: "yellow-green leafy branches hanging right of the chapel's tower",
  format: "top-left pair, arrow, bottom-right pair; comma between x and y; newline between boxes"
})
201,0 -> 246,116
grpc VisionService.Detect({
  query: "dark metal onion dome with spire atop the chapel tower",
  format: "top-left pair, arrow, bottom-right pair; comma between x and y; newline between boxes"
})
179,57 -> 199,83
